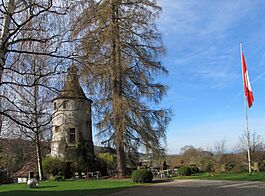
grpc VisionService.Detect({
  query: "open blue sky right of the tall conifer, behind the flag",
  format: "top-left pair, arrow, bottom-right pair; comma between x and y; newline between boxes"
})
158,0 -> 265,154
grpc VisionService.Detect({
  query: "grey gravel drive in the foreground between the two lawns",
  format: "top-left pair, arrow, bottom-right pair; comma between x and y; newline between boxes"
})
110,180 -> 265,196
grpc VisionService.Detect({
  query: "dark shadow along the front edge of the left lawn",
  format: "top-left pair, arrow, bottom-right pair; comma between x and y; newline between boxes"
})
0,186 -> 129,196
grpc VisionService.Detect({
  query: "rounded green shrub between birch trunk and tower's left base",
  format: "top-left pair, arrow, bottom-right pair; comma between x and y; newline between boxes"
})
42,157 -> 66,178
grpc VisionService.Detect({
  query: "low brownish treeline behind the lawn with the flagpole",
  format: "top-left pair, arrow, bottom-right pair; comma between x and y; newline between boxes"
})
167,136 -> 265,173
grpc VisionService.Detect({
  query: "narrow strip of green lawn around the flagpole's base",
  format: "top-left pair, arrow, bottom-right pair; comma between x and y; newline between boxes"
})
174,173 -> 265,181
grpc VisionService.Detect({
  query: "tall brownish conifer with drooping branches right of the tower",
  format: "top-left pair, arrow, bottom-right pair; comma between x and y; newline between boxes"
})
73,0 -> 170,177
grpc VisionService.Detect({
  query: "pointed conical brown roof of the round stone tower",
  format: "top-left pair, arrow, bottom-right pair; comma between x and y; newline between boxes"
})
53,66 -> 92,103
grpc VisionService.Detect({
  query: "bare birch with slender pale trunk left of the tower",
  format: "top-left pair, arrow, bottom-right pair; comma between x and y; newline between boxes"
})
0,0 -> 73,179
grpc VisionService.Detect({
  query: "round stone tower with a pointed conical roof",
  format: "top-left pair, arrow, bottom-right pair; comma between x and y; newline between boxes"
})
51,66 -> 94,163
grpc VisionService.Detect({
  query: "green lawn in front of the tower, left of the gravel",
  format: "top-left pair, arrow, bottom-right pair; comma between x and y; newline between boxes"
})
0,179 -> 139,196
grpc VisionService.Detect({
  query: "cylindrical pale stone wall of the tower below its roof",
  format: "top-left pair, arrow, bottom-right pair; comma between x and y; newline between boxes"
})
51,96 -> 93,161
